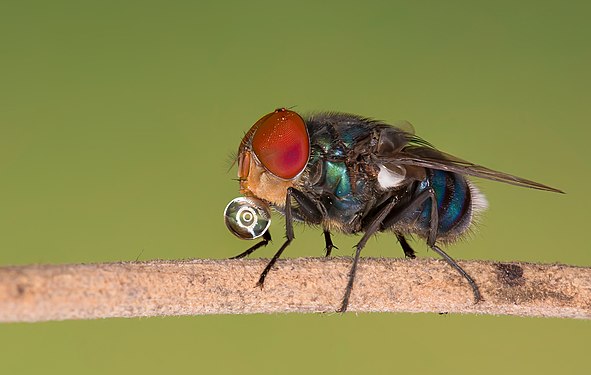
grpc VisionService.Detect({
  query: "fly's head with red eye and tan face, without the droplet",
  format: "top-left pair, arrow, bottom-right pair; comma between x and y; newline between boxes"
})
238,109 -> 310,207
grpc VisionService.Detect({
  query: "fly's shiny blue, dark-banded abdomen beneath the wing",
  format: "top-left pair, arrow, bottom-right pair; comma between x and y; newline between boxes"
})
416,169 -> 476,237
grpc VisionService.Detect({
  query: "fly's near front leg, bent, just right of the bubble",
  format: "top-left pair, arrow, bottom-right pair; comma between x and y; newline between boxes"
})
257,187 -> 322,288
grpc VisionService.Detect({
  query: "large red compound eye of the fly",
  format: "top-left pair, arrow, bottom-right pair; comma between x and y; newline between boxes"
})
249,108 -> 310,180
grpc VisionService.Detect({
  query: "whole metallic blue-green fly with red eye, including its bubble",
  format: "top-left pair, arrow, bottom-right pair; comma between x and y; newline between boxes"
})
224,108 -> 563,312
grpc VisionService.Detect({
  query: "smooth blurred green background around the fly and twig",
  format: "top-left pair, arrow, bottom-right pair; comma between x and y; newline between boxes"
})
0,0 -> 591,374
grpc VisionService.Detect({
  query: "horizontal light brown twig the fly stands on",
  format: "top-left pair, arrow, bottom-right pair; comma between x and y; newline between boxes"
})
0,258 -> 591,322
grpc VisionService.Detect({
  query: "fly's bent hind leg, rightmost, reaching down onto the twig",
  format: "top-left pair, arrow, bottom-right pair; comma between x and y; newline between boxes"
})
383,188 -> 482,303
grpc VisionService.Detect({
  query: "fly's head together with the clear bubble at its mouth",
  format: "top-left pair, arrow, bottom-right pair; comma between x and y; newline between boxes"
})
224,109 -> 310,243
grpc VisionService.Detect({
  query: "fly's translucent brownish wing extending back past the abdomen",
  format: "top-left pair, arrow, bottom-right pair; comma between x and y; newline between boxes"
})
380,133 -> 564,193
